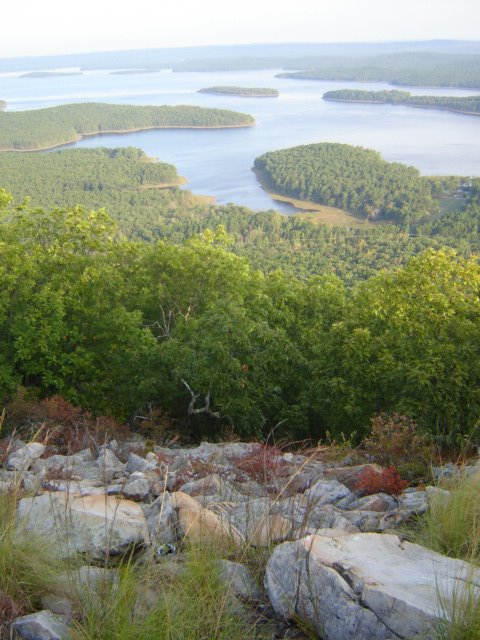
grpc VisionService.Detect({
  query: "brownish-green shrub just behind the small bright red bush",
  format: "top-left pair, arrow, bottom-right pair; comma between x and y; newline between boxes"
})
362,413 -> 433,481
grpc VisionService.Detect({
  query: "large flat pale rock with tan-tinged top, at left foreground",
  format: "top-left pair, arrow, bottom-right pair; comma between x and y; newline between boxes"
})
18,492 -> 150,558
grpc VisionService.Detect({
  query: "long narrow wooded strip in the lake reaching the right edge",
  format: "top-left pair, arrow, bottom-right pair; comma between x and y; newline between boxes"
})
323,89 -> 480,115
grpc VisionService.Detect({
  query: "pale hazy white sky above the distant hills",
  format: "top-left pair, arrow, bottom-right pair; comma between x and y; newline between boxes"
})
0,0 -> 480,57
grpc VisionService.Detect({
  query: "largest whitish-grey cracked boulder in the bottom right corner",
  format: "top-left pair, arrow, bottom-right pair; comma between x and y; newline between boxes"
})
265,533 -> 480,640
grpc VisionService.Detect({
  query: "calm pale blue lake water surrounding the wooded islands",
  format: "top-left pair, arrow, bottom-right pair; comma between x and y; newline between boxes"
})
0,70 -> 480,211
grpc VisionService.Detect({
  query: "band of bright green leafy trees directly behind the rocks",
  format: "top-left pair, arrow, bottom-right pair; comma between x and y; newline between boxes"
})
0,191 -> 480,444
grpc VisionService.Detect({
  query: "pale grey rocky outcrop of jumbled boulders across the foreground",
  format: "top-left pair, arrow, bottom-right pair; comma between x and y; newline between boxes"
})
0,436 -> 480,640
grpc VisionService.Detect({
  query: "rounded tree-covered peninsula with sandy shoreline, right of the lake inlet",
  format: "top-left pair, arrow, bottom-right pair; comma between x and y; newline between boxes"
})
255,143 -> 435,224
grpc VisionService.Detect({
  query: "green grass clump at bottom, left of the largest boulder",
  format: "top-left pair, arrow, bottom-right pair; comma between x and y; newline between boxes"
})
76,543 -> 268,640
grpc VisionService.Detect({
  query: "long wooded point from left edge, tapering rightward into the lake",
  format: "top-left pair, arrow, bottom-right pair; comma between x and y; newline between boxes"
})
0,102 -> 255,151
